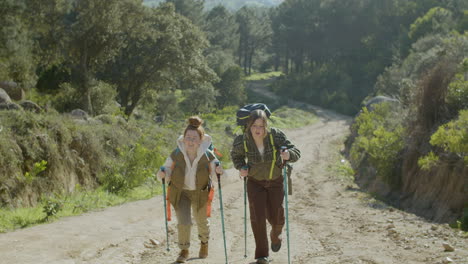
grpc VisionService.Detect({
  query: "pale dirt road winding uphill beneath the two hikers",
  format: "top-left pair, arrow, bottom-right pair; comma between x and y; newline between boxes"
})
0,105 -> 468,264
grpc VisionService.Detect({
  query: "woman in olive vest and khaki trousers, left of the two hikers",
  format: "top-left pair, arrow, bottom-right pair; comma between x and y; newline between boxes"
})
157,116 -> 223,263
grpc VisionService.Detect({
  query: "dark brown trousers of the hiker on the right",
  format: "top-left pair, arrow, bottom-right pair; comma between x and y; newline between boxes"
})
247,176 -> 284,258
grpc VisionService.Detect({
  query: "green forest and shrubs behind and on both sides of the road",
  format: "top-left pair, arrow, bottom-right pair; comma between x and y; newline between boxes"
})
0,0 -> 468,232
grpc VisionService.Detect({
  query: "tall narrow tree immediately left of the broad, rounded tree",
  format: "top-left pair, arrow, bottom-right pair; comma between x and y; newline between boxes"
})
66,0 -> 127,114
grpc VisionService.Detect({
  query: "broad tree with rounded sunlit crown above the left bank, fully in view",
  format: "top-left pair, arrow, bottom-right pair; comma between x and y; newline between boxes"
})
102,4 -> 218,116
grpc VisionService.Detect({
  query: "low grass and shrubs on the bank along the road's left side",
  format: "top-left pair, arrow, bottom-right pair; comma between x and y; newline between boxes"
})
0,104 -> 316,232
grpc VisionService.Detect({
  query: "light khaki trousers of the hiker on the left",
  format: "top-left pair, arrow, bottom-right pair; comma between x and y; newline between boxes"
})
176,190 -> 210,249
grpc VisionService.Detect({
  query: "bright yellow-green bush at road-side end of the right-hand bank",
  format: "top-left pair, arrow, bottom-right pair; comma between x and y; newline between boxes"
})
351,103 -> 405,184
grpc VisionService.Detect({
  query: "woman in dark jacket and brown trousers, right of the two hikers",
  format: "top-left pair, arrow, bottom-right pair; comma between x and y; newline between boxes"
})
231,110 -> 301,264
